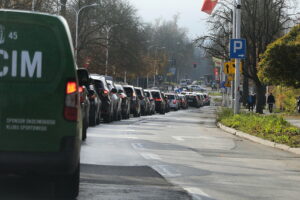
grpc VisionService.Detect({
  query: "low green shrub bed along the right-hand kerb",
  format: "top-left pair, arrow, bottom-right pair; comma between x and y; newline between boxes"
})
217,108 -> 300,147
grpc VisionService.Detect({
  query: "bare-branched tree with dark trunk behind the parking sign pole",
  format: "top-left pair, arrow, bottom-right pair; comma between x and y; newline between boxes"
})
196,0 -> 293,113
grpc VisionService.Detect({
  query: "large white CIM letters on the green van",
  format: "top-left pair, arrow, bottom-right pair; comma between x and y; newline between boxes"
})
0,49 -> 42,78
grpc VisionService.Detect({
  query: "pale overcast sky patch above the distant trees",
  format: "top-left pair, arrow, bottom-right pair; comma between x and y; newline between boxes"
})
127,0 -> 300,38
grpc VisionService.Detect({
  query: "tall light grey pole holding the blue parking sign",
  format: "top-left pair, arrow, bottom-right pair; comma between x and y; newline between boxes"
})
234,0 -> 241,114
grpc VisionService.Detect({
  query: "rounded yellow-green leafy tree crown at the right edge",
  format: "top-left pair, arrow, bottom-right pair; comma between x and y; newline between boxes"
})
258,25 -> 300,88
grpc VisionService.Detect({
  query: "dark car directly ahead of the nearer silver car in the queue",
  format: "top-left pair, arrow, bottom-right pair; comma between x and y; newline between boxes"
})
123,85 -> 141,117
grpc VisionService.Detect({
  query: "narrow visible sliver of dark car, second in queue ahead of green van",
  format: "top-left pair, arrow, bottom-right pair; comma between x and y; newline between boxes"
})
88,81 -> 102,126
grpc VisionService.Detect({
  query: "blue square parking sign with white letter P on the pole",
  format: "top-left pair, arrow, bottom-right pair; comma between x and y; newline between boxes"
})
230,39 -> 246,59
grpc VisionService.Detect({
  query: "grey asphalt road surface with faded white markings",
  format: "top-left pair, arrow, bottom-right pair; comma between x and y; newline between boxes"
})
0,107 -> 300,200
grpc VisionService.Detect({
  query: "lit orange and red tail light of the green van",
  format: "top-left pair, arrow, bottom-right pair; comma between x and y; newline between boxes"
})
64,81 -> 79,121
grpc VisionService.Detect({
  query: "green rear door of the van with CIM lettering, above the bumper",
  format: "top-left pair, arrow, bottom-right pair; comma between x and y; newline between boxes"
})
0,10 -> 81,152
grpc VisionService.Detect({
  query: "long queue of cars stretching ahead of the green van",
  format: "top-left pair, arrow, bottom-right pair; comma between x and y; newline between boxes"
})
77,68 -> 210,140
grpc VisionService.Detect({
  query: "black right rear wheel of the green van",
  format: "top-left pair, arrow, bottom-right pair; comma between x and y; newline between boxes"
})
55,163 -> 80,199
